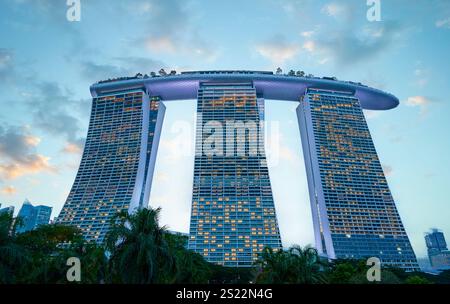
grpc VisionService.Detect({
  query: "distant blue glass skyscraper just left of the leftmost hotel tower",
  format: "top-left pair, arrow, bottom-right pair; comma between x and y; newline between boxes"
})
16,200 -> 52,233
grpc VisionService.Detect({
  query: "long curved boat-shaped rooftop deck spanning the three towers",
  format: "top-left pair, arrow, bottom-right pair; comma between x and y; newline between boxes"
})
91,72 -> 399,110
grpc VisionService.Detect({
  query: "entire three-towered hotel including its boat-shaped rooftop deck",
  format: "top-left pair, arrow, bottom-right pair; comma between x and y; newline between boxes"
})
57,71 -> 418,270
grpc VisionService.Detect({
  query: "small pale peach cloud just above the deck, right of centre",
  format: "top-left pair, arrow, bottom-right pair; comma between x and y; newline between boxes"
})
256,35 -> 300,66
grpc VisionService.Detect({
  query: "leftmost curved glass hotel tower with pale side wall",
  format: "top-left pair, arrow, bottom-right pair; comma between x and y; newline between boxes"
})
57,90 -> 164,242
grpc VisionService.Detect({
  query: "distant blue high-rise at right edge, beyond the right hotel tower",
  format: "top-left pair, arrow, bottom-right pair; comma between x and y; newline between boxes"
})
425,229 -> 450,270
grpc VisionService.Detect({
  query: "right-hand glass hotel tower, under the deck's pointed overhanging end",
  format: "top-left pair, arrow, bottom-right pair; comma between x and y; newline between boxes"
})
297,89 -> 418,270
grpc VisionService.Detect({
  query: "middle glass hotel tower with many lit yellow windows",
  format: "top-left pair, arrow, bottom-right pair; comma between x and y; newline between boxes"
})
188,83 -> 281,267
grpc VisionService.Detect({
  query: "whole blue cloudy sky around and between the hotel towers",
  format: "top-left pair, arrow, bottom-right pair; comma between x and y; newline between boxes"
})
0,0 -> 450,256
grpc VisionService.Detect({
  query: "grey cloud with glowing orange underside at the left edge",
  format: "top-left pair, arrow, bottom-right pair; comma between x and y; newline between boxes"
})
0,126 -> 55,180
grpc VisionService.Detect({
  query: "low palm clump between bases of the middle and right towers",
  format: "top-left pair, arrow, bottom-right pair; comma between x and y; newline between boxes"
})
256,246 -> 325,284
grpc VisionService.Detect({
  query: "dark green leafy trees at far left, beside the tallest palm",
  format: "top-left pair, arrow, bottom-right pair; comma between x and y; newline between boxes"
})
0,210 -> 106,284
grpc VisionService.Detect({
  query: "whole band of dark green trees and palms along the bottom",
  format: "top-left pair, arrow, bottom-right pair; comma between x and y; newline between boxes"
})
0,209 -> 450,284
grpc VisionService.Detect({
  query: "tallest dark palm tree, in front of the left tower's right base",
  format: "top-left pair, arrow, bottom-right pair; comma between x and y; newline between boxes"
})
106,208 -> 175,284
